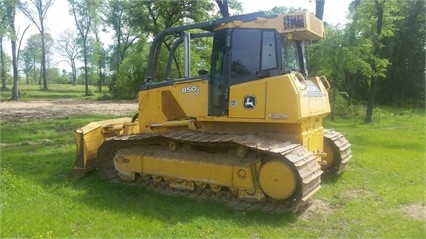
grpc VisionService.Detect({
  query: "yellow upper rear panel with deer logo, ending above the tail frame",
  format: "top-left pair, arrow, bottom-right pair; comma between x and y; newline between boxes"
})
198,74 -> 330,124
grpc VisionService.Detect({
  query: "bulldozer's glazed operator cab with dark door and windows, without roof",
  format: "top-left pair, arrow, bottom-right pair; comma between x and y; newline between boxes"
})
209,28 -> 307,116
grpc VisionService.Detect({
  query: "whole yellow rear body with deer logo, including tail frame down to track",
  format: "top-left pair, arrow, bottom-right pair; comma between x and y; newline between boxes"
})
197,74 -> 330,157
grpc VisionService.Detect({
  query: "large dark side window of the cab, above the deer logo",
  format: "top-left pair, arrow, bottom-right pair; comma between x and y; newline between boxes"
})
231,29 -> 260,80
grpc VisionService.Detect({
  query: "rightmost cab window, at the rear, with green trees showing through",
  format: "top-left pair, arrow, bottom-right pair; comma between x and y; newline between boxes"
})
282,38 -> 303,72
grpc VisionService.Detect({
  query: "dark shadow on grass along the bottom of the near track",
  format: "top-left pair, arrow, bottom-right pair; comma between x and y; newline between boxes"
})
60,172 -> 297,227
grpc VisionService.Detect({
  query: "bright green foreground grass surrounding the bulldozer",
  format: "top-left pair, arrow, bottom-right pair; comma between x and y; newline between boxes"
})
0,108 -> 426,238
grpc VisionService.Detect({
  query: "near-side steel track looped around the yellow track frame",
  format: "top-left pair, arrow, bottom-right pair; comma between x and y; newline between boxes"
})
96,130 -> 322,213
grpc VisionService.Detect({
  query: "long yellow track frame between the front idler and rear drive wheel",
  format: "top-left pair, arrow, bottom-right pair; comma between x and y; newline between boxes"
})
114,146 -> 255,190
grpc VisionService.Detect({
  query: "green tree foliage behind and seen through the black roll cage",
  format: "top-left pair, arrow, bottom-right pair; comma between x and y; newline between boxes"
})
108,0 -> 213,98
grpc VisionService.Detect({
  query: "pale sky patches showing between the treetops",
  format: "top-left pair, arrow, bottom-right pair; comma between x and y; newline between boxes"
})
11,0 -> 352,69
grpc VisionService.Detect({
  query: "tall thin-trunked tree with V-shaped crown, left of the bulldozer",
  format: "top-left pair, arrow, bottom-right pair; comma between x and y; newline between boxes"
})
68,0 -> 101,96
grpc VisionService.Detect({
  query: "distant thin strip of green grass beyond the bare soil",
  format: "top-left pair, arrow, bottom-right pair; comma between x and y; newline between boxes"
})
0,84 -> 109,101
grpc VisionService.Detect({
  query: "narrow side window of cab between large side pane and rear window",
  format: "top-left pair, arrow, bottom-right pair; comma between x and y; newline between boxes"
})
262,31 -> 277,70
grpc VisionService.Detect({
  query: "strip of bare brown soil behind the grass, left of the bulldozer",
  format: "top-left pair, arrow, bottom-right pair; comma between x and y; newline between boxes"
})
0,99 -> 138,122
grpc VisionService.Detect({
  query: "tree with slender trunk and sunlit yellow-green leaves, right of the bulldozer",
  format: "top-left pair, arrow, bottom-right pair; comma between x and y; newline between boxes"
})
346,0 -> 398,123
